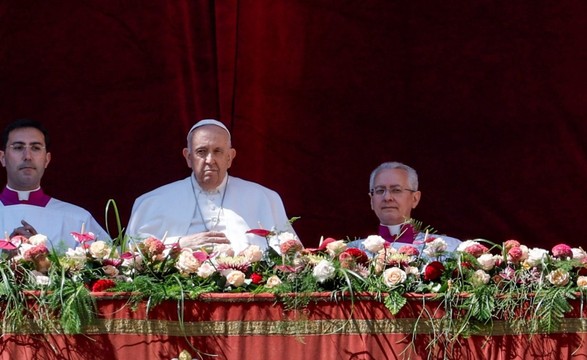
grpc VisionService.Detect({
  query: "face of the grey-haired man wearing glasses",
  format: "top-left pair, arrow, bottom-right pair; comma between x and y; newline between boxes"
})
370,169 -> 421,225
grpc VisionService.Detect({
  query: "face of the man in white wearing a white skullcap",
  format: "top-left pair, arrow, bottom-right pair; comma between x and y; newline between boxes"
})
183,125 -> 236,191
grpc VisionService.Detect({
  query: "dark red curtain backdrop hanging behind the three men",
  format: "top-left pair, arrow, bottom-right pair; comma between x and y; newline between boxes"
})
0,0 -> 587,247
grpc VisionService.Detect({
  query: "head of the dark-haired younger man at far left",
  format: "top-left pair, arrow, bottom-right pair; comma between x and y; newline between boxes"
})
0,127 -> 51,190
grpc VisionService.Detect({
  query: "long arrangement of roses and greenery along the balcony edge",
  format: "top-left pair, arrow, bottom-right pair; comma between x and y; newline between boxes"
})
0,217 -> 587,341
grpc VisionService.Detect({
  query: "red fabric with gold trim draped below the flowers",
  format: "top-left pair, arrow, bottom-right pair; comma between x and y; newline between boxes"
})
0,294 -> 587,360
